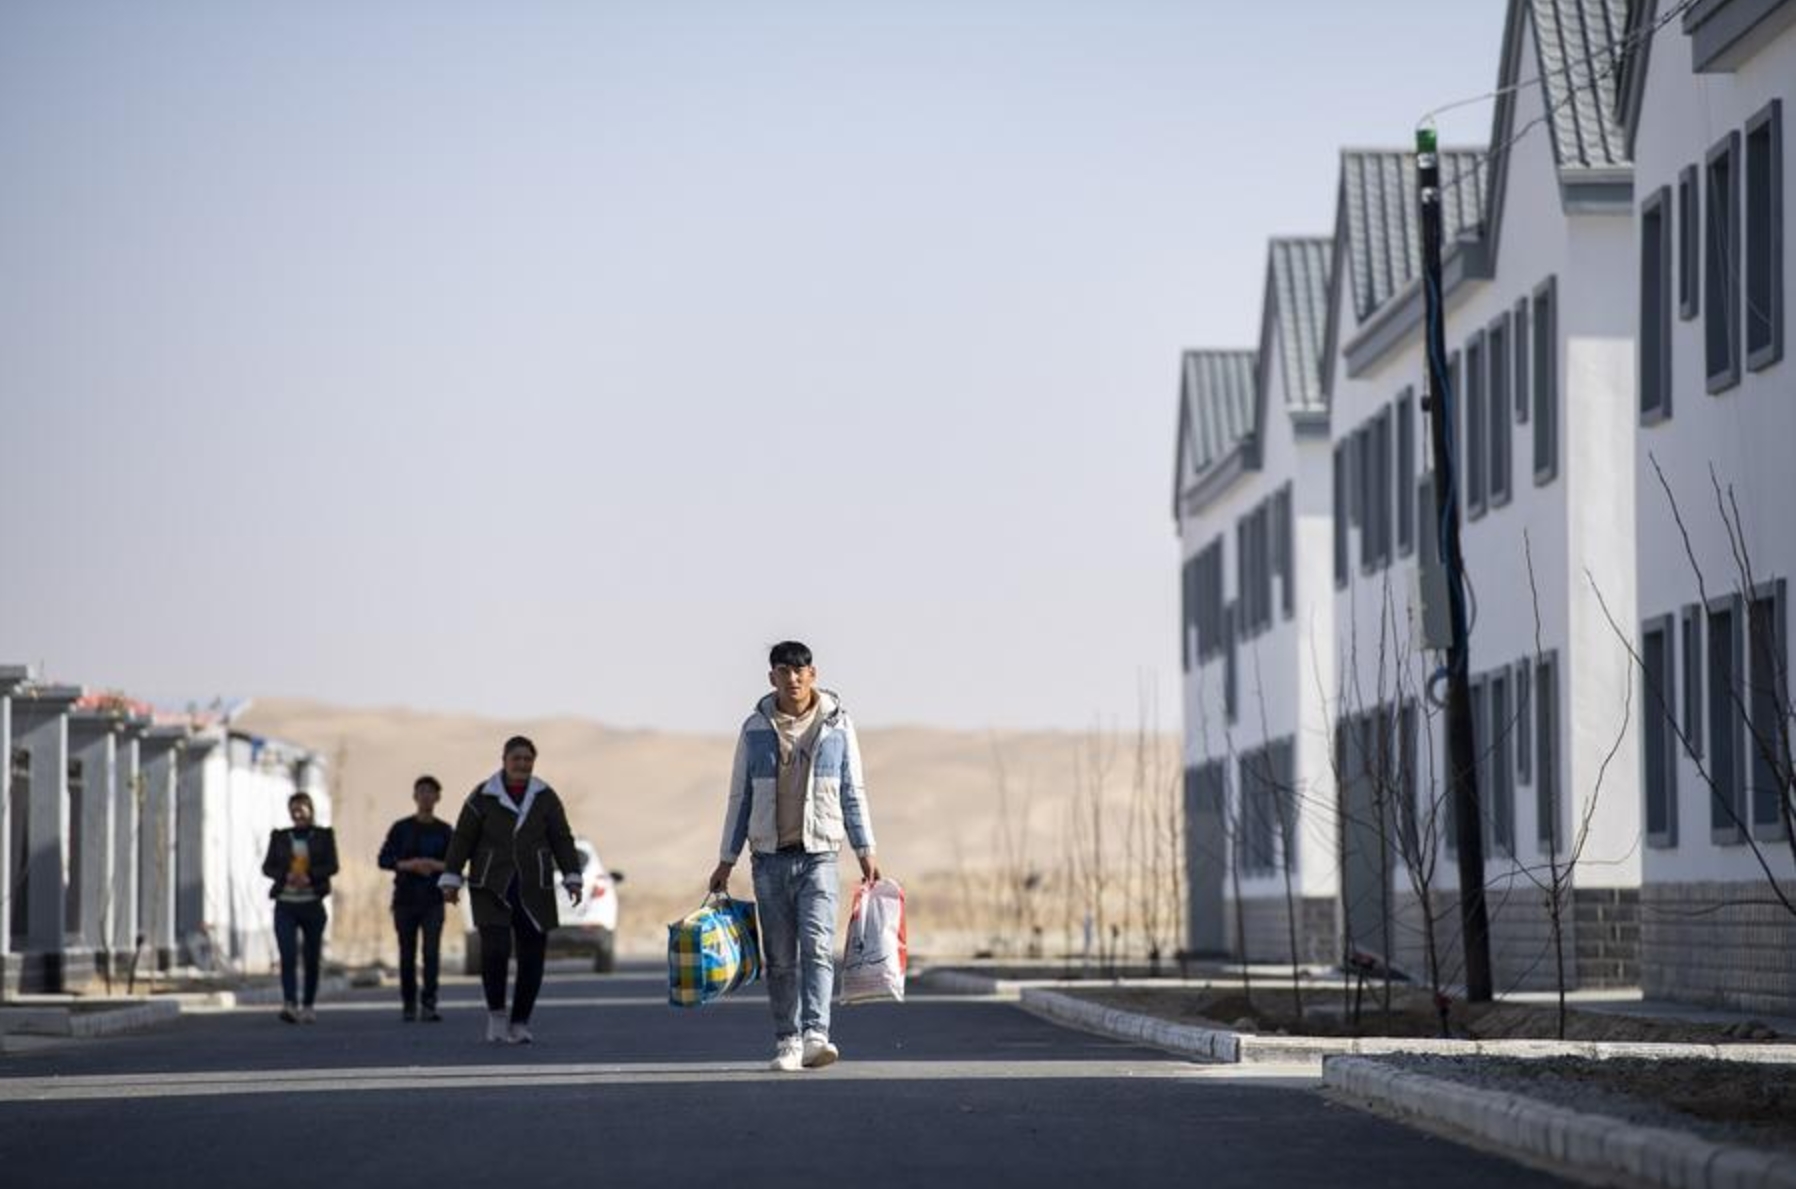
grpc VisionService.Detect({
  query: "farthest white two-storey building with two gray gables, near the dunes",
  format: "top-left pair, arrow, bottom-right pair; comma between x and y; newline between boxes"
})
1173,239 -> 1340,963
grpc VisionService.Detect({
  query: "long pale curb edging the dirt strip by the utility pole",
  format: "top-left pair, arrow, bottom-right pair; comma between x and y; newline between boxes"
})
1018,986 -> 1796,1070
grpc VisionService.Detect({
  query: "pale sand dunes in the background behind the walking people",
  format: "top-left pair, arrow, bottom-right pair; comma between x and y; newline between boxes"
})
239,699 -> 1178,954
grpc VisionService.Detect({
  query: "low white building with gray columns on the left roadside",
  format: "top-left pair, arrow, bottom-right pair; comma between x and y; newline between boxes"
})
0,678 -> 330,995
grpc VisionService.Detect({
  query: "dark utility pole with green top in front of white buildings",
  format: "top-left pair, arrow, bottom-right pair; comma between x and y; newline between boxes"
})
1415,128 -> 1492,1004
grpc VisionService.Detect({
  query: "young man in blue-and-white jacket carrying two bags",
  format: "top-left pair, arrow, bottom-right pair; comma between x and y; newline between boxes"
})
711,639 -> 880,1072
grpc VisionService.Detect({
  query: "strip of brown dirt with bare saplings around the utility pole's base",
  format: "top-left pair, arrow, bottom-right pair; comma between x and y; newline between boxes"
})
1063,984 -> 1796,1044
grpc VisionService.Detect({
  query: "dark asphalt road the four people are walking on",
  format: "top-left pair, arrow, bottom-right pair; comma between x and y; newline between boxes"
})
0,970 -> 1561,1189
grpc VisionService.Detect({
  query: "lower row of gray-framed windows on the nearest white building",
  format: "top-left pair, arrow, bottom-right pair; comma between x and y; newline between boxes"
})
1640,578 -> 1791,848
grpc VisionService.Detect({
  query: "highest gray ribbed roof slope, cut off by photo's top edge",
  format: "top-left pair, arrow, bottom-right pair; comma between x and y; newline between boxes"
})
1510,0 -> 1629,169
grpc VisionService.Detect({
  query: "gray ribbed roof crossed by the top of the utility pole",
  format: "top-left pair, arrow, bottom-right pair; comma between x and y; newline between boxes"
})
1342,149 -> 1487,321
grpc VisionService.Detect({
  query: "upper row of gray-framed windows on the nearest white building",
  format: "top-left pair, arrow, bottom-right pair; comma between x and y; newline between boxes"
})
1638,99 -> 1783,424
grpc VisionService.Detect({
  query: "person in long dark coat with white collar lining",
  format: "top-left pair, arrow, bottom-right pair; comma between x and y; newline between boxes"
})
440,735 -> 580,1045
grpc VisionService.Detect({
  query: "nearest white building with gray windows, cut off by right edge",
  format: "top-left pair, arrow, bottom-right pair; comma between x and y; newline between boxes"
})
1620,0 -> 1796,1013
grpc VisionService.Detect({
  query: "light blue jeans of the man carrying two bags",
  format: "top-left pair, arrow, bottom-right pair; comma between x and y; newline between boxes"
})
754,850 -> 841,1040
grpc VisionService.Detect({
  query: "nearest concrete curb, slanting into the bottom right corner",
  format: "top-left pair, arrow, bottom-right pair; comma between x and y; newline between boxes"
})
1322,1056 -> 1796,1189
